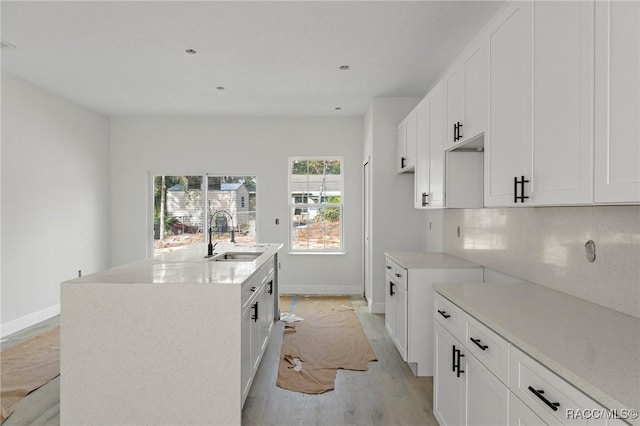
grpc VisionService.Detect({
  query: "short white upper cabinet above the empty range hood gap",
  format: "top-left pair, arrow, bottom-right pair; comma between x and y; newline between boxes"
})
444,44 -> 487,148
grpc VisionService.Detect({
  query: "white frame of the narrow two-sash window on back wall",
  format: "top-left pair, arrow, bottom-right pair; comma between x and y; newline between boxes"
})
287,155 -> 346,255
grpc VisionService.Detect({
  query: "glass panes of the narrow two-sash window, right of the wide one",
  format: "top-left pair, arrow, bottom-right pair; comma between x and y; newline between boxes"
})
289,157 -> 344,253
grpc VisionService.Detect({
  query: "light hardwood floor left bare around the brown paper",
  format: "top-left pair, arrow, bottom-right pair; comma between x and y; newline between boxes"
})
2,298 -> 438,426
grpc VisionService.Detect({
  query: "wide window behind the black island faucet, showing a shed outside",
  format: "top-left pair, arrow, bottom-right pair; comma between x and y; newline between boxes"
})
153,174 -> 257,254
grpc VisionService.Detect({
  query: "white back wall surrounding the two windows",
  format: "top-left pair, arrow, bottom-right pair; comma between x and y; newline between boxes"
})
111,117 -> 363,294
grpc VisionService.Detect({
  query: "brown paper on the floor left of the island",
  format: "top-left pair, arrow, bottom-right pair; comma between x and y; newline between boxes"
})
0,327 -> 60,423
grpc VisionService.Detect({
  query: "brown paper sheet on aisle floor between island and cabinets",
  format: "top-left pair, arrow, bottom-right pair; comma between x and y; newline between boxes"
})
276,296 -> 377,394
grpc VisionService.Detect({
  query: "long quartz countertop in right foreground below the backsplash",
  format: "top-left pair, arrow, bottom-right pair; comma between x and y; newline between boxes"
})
434,283 -> 640,425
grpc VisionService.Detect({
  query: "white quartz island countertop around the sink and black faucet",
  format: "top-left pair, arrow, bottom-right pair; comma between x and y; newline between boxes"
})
65,243 -> 282,284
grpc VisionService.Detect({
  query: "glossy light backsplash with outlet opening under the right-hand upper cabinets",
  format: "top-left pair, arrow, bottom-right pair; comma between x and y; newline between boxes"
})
442,206 -> 640,318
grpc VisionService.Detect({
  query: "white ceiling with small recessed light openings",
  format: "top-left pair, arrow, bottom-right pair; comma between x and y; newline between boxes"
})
0,0 -> 502,116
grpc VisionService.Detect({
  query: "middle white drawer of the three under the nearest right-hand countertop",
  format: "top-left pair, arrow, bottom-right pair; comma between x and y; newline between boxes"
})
463,314 -> 510,385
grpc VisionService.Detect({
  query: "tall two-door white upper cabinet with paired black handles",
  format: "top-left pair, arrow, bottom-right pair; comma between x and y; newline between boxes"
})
485,1 -> 595,206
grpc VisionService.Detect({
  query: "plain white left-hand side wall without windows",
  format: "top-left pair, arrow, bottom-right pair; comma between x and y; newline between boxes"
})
1,73 -> 109,335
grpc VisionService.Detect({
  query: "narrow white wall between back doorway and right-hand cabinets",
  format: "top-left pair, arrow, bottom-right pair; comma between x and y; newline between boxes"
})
364,98 -> 426,312
